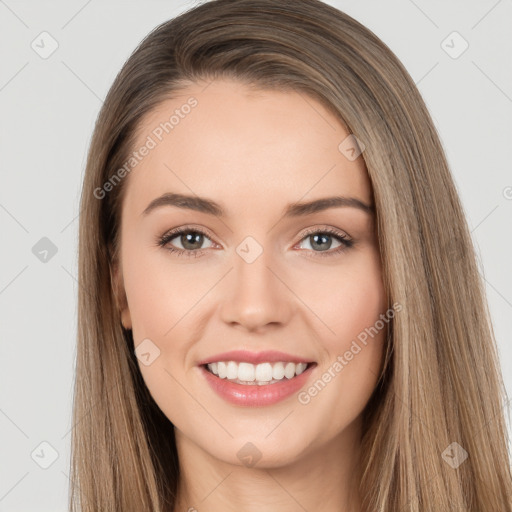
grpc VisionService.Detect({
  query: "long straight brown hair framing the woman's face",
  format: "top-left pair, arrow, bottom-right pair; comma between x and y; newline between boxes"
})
70,0 -> 512,512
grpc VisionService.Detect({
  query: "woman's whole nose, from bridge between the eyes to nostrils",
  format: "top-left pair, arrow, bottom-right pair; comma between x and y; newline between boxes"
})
222,237 -> 291,330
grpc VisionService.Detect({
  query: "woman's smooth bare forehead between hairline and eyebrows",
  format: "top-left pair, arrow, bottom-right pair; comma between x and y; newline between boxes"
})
125,80 -> 372,219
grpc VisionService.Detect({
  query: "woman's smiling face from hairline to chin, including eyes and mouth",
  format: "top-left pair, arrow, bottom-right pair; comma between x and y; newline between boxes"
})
117,80 -> 387,467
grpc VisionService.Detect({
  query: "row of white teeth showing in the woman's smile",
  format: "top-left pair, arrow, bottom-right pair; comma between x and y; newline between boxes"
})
207,361 -> 307,386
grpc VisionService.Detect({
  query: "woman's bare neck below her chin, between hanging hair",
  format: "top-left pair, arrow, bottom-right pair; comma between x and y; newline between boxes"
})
173,421 -> 361,512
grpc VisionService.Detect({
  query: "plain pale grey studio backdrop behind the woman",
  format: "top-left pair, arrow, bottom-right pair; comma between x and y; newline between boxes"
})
0,0 -> 512,512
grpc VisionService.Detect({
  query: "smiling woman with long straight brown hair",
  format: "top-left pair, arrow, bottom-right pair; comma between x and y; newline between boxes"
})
71,0 -> 512,512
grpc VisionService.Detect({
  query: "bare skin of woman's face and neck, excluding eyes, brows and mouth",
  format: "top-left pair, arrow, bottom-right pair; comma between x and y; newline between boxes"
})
116,80 -> 387,512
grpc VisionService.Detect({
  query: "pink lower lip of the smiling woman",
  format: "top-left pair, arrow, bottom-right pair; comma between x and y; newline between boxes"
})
199,364 -> 316,407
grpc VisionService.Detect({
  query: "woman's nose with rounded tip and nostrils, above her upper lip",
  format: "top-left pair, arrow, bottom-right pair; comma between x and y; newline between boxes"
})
221,246 -> 294,332
